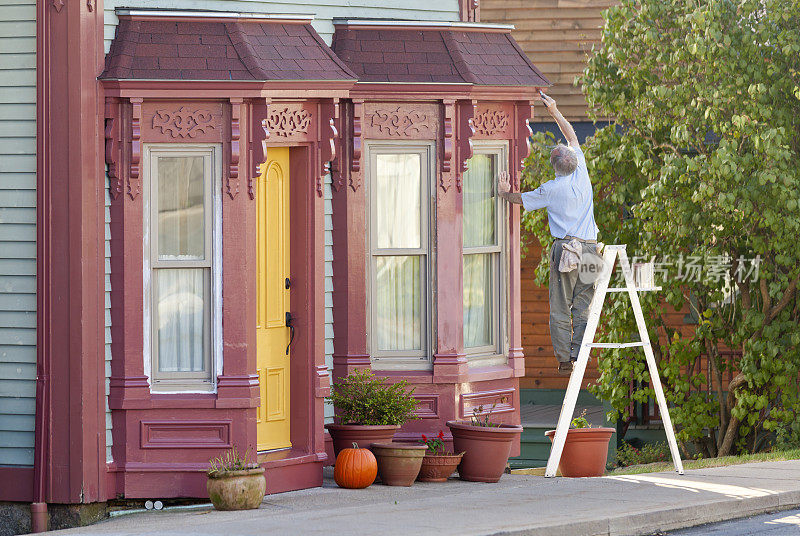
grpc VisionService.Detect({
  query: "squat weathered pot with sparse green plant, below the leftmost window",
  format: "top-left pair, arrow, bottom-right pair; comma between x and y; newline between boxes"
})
206,447 -> 267,510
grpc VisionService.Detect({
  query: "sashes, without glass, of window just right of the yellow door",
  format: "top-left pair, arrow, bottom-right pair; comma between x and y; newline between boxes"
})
366,142 -> 433,368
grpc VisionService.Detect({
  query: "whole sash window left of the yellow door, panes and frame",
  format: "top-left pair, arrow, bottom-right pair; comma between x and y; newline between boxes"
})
144,146 -> 220,391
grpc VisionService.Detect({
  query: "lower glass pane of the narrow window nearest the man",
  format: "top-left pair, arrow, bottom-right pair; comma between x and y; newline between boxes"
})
464,253 -> 494,348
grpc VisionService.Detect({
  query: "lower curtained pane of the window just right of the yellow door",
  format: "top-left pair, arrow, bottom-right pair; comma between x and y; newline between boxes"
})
375,256 -> 422,350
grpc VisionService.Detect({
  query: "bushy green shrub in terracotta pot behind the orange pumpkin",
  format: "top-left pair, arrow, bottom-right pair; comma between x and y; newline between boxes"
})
325,370 -> 417,456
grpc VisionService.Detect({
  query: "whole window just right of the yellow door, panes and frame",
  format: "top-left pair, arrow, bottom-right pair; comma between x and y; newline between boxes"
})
367,144 -> 433,368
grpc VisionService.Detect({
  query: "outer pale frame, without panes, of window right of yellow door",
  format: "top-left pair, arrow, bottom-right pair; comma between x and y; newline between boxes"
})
364,141 -> 436,370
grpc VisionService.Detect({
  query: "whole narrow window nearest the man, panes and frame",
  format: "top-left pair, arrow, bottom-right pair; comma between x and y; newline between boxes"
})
462,144 -> 505,357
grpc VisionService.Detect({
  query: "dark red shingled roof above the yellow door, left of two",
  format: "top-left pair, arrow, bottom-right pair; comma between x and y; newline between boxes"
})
100,18 -> 356,80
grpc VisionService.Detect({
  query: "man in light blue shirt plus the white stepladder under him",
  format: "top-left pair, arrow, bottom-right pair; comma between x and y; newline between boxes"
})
497,93 -> 683,477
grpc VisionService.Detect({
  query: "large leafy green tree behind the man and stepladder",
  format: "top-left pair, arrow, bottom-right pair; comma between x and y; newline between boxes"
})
523,0 -> 800,456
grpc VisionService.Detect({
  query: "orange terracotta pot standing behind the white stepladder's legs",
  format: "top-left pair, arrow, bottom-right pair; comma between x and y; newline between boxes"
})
544,428 -> 615,478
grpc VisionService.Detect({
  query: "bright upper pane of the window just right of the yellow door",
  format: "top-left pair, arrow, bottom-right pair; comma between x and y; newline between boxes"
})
374,154 -> 422,249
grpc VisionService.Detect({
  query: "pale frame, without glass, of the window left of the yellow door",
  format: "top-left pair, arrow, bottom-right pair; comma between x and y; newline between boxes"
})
142,143 -> 222,393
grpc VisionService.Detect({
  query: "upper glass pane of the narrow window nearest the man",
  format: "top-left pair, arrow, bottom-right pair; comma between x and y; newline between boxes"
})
463,154 -> 496,247
